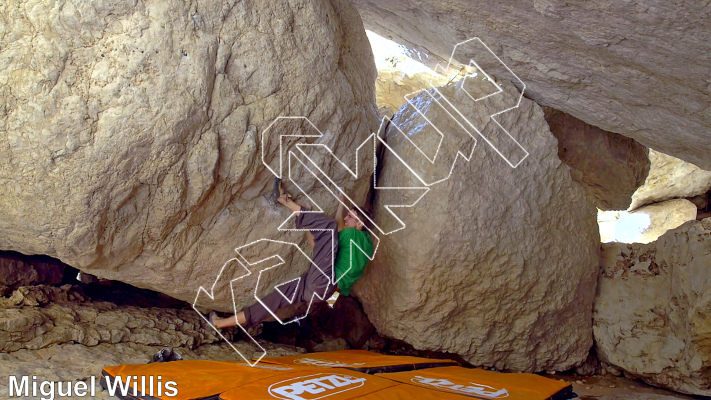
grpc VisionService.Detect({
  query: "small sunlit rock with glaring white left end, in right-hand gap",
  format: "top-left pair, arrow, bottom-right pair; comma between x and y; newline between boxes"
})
615,199 -> 697,243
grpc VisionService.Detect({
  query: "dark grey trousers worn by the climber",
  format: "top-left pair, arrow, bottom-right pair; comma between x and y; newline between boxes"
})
244,211 -> 338,326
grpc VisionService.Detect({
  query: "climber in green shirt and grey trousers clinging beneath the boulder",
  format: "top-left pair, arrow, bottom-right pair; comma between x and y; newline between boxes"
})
209,180 -> 373,329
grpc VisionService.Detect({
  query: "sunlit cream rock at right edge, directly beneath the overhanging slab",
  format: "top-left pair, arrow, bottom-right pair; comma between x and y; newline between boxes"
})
630,150 -> 711,210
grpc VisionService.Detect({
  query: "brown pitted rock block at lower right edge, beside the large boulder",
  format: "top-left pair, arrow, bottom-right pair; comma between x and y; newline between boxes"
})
593,218 -> 711,396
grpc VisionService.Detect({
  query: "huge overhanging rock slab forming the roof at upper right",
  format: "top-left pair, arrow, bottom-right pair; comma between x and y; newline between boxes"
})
354,0 -> 711,170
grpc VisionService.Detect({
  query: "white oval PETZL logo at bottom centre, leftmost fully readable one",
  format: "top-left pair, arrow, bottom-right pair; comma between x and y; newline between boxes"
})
269,374 -> 365,400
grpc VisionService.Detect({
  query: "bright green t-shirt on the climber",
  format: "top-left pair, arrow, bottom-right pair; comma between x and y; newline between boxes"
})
335,228 -> 373,296
